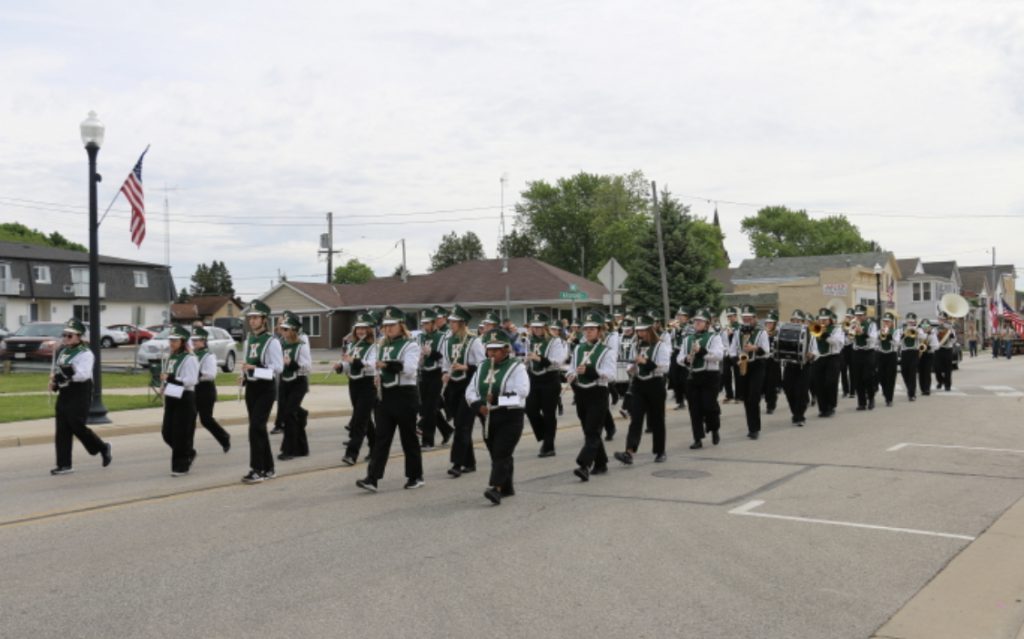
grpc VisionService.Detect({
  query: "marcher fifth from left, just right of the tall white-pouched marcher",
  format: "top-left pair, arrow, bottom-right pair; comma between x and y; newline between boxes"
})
278,313 -> 313,462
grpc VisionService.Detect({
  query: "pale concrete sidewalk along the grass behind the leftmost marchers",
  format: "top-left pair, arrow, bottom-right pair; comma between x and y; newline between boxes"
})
0,385 -> 352,449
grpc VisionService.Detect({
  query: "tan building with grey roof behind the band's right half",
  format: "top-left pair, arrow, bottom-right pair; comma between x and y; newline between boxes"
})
724,252 -> 901,321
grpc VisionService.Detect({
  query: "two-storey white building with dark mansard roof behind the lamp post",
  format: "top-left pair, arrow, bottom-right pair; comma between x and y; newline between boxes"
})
0,242 -> 175,330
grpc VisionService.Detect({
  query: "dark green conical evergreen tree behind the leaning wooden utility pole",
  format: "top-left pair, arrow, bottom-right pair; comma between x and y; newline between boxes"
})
625,189 -> 724,312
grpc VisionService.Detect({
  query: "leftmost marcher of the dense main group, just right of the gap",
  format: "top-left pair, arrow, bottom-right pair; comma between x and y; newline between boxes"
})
334,311 -> 377,466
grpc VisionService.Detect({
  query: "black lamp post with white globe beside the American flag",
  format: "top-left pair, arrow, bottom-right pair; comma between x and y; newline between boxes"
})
79,111 -> 111,424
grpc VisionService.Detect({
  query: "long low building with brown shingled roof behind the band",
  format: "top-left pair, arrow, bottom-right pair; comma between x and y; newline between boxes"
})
259,257 -> 608,348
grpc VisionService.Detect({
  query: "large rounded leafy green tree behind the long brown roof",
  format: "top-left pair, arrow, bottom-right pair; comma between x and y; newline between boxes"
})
516,171 -> 650,278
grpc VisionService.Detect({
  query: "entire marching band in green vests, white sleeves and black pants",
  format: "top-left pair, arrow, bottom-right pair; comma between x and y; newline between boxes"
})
50,301 -> 963,505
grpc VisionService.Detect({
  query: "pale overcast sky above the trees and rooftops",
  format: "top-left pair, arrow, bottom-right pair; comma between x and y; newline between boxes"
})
0,0 -> 1024,298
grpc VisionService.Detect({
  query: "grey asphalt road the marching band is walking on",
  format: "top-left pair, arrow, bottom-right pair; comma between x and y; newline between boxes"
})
0,356 -> 1024,639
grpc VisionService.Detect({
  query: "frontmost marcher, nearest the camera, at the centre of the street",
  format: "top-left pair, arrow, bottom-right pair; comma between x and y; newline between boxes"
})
466,329 -> 537,506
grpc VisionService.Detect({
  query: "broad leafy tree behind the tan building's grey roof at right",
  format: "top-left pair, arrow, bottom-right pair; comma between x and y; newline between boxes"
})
741,206 -> 881,257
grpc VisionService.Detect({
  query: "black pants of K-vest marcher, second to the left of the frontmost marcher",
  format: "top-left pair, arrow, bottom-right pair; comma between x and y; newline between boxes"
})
367,386 -> 423,479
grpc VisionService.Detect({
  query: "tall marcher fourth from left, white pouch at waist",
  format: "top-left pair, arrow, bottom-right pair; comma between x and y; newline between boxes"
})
241,300 -> 285,483
